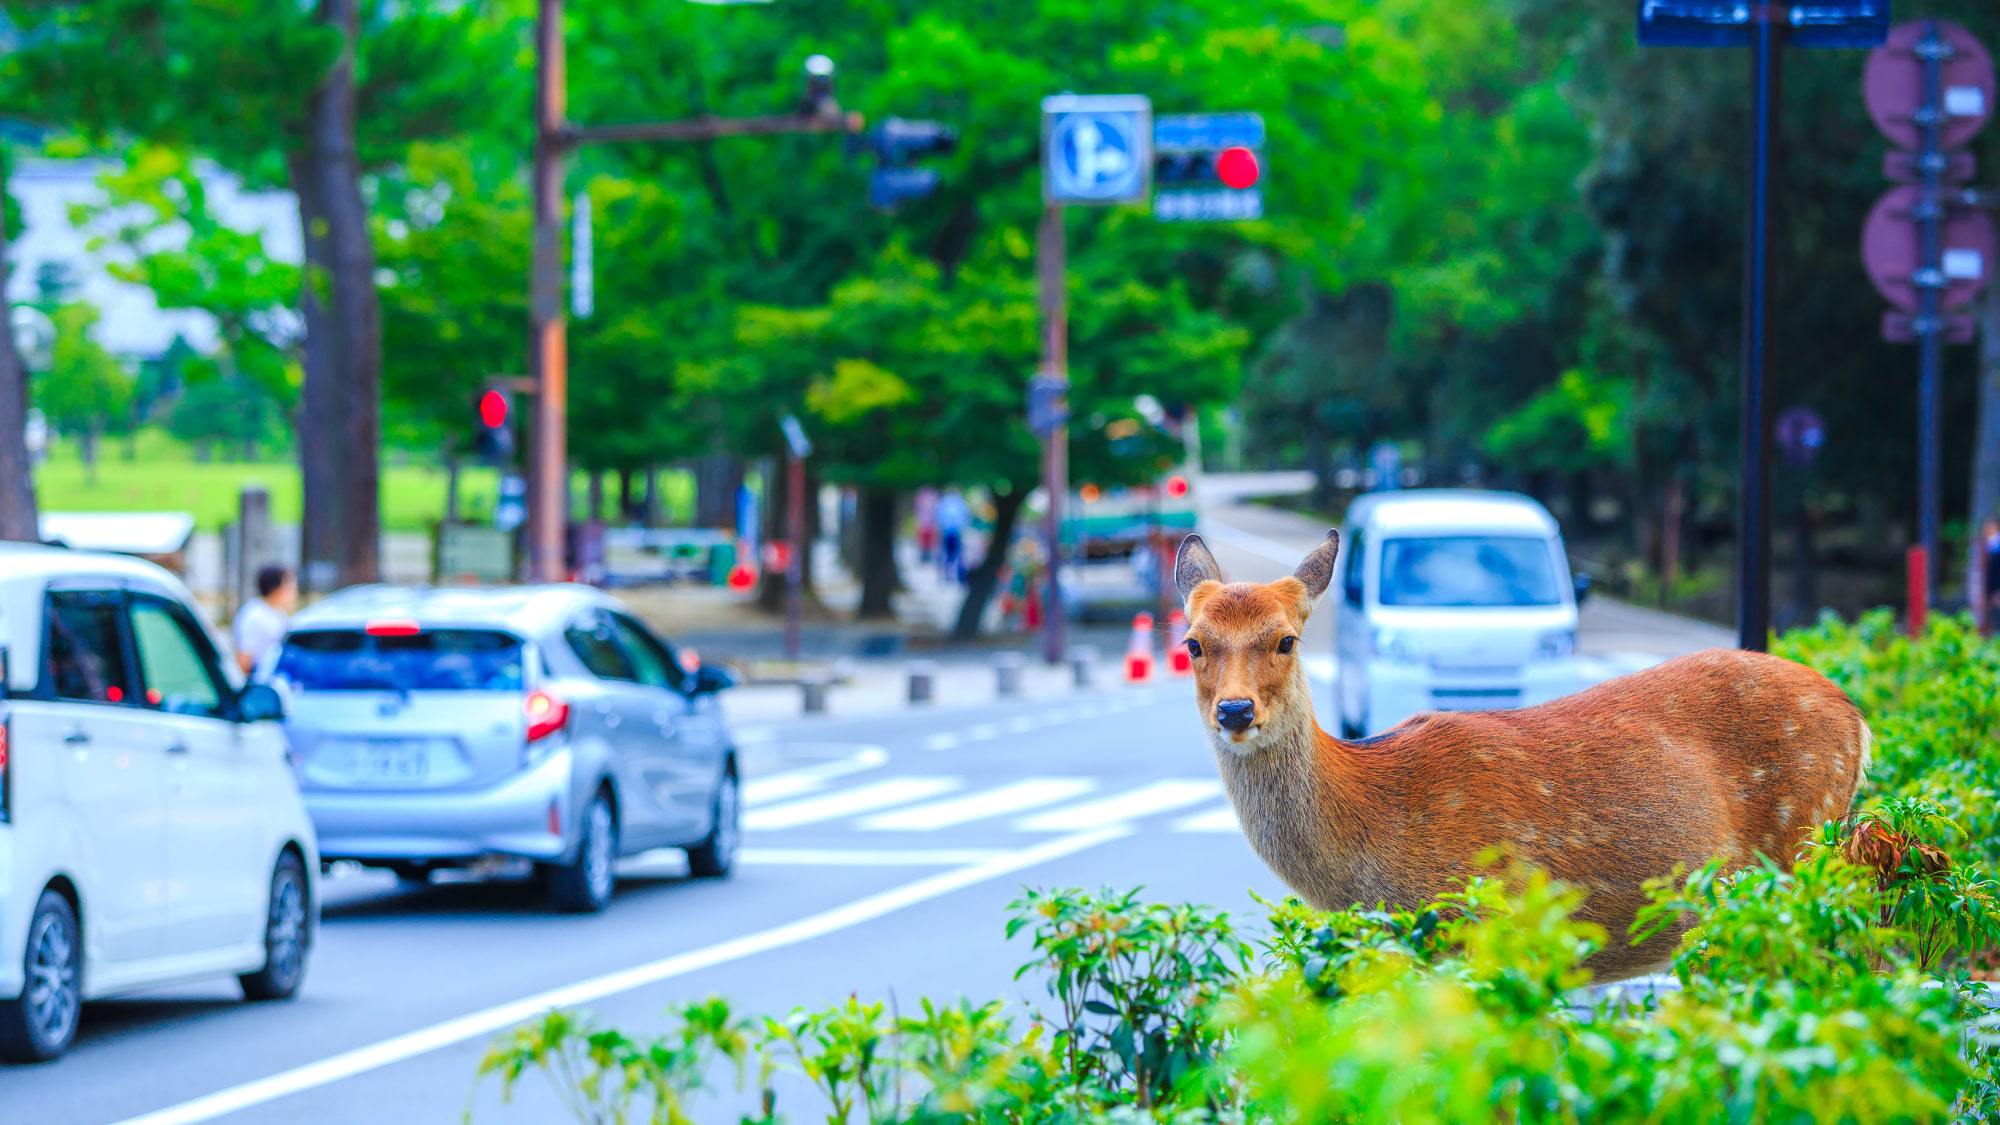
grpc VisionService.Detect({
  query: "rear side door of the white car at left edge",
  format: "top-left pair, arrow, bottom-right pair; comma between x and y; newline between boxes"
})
14,585 -> 168,964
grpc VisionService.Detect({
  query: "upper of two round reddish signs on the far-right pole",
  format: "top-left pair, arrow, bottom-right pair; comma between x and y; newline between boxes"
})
1862,20 -> 1994,148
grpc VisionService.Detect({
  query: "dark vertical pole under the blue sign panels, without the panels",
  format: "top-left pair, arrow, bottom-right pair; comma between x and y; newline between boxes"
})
1736,12 -> 1784,651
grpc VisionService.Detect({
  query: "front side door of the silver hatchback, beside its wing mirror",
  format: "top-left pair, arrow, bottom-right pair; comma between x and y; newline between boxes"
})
610,613 -> 726,841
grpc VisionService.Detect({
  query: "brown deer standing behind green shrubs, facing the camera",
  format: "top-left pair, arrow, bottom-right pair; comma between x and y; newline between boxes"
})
1174,530 -> 1874,979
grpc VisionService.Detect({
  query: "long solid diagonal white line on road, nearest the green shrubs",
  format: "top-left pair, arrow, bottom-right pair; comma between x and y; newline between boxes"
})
120,827 -> 1128,1125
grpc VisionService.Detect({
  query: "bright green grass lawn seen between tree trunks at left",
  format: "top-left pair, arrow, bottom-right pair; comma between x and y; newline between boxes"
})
34,430 -> 694,532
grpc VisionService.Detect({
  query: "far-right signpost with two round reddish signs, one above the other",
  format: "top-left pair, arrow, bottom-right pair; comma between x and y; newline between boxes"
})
1862,20 -> 1994,620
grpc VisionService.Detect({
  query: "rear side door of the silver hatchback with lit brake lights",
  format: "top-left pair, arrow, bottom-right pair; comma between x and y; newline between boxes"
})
562,609 -> 682,849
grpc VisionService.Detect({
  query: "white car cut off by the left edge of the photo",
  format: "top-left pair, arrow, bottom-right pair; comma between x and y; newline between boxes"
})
0,544 -> 320,1061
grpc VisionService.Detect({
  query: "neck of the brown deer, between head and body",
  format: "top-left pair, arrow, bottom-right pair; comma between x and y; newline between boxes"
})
1216,685 -> 1396,909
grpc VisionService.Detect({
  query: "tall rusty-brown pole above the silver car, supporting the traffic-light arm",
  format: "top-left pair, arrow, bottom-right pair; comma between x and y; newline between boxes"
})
528,0 -> 570,583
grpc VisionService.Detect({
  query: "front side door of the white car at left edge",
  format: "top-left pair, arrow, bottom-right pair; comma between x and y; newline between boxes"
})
126,593 -> 276,955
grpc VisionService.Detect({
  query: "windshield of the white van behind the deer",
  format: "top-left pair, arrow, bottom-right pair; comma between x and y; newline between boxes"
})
1380,534 -> 1562,607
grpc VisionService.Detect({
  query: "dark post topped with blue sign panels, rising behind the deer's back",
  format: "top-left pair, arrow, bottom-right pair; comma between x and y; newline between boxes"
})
1638,0 -> 1890,651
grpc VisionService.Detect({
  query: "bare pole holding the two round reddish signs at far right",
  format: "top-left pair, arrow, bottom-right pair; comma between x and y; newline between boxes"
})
1912,22 -> 1948,621
